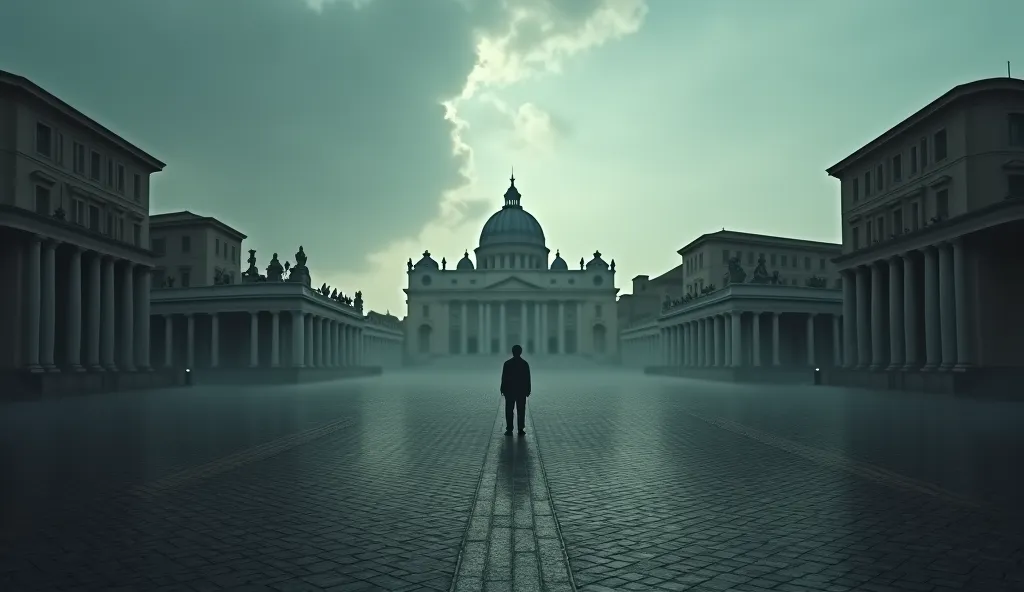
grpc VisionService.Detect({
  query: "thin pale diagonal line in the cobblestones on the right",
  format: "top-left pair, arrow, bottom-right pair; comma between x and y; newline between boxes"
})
687,412 -> 989,510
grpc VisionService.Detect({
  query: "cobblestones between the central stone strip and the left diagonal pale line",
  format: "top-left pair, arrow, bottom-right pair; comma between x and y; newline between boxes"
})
0,381 -> 495,592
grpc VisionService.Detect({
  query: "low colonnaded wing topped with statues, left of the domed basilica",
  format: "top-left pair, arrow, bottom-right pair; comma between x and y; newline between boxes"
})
151,239 -> 403,383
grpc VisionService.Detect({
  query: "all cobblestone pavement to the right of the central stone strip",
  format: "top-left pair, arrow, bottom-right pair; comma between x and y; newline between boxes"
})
530,370 -> 1024,592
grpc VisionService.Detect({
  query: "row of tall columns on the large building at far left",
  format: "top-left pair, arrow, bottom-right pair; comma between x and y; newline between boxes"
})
24,235 -> 151,372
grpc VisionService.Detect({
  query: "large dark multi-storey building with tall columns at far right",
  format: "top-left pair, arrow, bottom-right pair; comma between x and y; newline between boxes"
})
826,78 -> 1024,392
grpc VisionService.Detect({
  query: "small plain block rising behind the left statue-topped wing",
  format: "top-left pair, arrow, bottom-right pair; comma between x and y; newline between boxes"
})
150,211 -> 246,288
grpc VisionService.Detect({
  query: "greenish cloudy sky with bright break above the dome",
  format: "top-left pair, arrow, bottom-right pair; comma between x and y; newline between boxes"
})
0,0 -> 1024,316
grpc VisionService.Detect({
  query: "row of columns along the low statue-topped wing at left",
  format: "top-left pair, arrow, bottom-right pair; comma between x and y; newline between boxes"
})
162,310 -> 364,368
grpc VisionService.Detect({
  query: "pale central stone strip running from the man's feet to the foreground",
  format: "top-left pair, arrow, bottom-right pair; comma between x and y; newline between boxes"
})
455,403 -> 574,592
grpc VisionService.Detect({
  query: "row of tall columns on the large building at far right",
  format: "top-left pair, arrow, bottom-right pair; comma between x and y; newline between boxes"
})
842,239 -> 974,372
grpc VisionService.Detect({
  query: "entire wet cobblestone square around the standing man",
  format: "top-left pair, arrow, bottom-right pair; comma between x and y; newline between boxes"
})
0,369 -> 1024,592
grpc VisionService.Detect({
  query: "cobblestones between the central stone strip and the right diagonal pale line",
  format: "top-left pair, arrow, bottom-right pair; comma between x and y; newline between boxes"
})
531,388 -> 1024,592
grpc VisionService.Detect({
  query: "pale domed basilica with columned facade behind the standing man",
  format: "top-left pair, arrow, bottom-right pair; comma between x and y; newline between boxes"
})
404,173 -> 617,362
